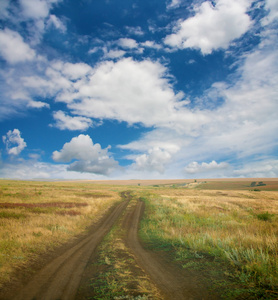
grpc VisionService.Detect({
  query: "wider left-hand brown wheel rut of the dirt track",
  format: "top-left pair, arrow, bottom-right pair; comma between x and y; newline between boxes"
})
13,199 -> 129,300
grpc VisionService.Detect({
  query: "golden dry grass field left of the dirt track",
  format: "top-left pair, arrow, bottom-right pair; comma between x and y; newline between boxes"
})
0,180 -> 120,288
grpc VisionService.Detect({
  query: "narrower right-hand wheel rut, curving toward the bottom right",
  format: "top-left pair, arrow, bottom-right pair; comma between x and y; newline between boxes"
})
122,200 -> 216,300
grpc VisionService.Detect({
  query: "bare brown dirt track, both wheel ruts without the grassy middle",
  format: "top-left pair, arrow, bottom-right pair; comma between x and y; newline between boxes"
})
5,191 -> 217,300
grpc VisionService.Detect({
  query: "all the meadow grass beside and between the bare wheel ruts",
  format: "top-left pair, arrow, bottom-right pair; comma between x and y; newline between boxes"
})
0,180 -> 278,299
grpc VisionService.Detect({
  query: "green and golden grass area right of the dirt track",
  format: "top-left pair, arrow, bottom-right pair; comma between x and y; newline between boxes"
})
140,188 -> 278,299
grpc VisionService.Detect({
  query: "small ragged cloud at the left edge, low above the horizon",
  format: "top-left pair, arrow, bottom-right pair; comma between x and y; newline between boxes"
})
2,129 -> 27,155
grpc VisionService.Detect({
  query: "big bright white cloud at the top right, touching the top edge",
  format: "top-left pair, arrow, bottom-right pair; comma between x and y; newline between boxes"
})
164,0 -> 251,54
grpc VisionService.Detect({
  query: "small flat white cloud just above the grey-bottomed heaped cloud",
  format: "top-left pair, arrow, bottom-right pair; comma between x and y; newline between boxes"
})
53,110 -> 92,130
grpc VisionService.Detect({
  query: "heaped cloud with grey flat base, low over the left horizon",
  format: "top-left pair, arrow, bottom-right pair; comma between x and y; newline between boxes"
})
52,134 -> 118,175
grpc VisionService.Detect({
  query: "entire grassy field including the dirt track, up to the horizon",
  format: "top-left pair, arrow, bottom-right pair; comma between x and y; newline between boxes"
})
0,179 -> 278,299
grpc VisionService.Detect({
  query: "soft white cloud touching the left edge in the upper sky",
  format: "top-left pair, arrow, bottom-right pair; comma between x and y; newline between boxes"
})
0,28 -> 36,64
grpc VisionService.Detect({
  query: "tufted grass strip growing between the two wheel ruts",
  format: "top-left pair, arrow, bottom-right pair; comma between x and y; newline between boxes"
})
78,202 -> 161,300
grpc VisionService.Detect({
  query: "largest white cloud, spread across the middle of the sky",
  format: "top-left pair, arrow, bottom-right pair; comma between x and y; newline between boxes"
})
22,58 -> 206,132
